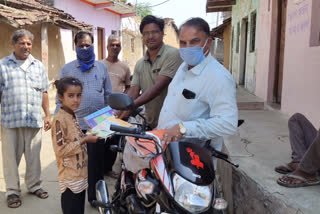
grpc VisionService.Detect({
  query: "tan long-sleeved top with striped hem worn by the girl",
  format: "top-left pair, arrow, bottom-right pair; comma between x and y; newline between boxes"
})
51,108 -> 88,193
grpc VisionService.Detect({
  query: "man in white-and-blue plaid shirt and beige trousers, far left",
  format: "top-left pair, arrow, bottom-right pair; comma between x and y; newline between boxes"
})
0,29 -> 51,208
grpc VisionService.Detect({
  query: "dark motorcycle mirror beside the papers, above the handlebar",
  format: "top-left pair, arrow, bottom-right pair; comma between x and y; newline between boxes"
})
108,93 -> 134,110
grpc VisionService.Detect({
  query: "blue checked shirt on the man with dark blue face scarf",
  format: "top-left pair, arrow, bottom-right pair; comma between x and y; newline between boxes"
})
55,60 -> 112,130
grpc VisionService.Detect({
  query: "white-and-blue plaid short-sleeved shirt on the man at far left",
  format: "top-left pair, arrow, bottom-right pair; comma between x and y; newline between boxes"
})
0,53 -> 49,128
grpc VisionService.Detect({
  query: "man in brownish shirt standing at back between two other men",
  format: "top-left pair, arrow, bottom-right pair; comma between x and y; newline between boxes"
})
102,35 -> 131,178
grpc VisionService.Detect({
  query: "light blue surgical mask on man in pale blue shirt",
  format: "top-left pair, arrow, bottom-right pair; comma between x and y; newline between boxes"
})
179,39 -> 209,66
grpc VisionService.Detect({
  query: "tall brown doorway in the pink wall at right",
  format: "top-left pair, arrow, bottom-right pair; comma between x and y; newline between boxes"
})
273,0 -> 287,105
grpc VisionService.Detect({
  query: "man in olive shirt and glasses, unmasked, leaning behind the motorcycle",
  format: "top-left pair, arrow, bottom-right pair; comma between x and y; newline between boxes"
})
117,15 -> 182,128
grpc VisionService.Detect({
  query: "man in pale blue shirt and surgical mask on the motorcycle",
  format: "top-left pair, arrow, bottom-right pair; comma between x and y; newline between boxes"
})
157,18 -> 238,150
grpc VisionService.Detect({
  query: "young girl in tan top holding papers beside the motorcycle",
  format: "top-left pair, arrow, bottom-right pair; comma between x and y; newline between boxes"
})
51,77 -> 98,214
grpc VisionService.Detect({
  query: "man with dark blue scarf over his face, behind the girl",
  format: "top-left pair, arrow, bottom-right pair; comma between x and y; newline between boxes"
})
55,31 -> 112,205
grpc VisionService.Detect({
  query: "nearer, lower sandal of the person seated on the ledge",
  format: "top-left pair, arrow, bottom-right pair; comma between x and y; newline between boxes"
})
277,173 -> 320,188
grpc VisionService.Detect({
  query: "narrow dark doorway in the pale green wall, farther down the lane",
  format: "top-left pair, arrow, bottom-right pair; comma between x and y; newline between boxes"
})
239,17 -> 249,86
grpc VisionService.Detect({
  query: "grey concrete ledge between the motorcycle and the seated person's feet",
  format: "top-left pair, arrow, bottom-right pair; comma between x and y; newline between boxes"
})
218,110 -> 320,214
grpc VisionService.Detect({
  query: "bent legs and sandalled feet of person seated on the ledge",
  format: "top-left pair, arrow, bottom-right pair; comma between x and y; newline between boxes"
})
275,113 -> 320,187
